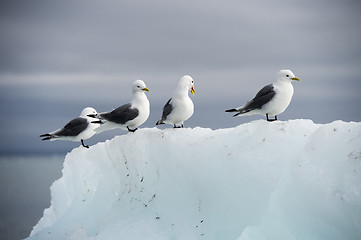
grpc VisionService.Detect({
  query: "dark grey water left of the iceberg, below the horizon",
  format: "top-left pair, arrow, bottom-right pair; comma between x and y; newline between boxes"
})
0,156 -> 65,240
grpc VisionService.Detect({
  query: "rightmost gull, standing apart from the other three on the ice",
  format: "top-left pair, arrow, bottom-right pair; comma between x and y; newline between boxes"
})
226,70 -> 300,122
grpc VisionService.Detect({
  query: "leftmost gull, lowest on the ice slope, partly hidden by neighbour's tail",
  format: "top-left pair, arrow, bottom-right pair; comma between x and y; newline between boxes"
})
40,107 -> 100,148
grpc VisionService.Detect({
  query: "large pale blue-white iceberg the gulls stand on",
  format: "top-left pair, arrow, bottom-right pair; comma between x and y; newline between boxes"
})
28,120 -> 361,240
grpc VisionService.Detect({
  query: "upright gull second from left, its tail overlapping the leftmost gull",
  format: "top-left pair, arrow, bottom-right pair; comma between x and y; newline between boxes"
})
88,80 -> 150,133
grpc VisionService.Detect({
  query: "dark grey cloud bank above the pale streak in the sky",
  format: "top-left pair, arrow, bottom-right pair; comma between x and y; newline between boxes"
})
2,1 -> 361,73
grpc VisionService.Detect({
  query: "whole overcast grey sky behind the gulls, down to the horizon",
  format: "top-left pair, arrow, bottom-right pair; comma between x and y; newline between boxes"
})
0,0 -> 361,154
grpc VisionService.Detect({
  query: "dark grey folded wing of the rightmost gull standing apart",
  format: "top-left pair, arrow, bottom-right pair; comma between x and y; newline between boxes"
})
242,84 -> 276,113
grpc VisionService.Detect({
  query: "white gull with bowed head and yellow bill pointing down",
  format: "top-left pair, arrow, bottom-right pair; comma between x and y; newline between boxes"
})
156,75 -> 195,128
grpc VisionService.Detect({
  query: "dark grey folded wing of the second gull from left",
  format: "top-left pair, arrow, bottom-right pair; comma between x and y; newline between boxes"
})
100,103 -> 139,124
